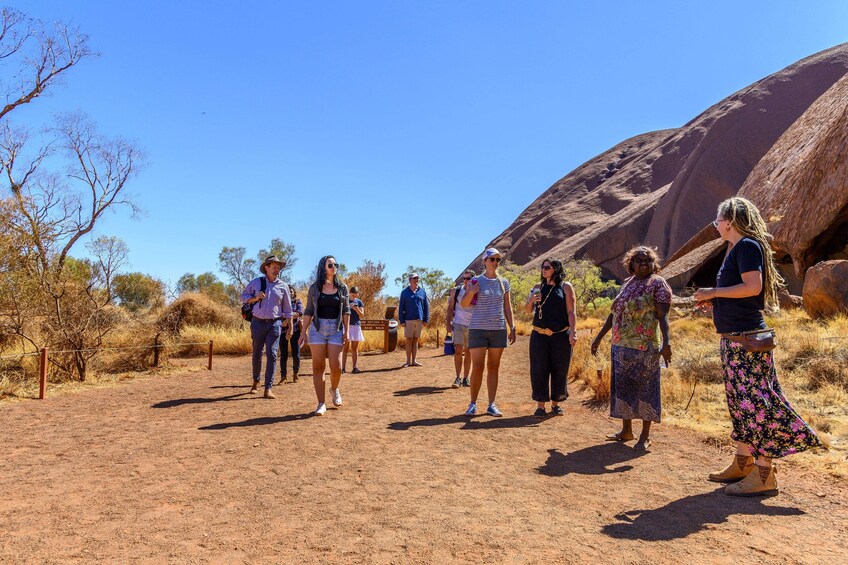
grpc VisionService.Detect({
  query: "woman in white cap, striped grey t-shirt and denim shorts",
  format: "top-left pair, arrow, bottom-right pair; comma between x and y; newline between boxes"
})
460,247 -> 515,416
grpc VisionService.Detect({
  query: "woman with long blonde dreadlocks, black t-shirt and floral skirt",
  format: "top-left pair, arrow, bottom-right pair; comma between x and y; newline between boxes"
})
695,197 -> 821,496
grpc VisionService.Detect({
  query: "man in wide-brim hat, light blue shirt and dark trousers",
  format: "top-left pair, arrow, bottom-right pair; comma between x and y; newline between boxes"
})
241,255 -> 292,398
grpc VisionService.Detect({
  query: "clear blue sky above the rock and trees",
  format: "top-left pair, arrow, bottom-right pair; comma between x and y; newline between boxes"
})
8,0 -> 848,292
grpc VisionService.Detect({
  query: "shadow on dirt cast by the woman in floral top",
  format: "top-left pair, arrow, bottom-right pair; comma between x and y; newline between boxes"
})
538,442 -> 648,477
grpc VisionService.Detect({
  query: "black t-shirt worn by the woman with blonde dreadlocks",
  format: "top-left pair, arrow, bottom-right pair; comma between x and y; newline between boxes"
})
713,237 -> 766,333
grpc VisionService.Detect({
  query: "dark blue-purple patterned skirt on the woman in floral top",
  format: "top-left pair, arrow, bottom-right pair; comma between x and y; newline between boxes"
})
610,345 -> 662,422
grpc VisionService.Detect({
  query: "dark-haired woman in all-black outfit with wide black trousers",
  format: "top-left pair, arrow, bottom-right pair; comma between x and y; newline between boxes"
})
524,259 -> 577,418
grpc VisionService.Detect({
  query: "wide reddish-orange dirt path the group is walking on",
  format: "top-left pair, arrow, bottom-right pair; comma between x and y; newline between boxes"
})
0,339 -> 848,564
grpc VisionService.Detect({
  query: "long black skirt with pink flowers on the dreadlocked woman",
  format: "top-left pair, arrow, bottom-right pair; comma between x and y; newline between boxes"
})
721,337 -> 821,458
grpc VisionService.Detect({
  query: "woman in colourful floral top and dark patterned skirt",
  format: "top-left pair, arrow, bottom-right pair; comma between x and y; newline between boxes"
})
592,246 -> 671,451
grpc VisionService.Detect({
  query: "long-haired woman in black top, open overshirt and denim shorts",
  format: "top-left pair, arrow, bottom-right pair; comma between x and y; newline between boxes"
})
298,255 -> 350,416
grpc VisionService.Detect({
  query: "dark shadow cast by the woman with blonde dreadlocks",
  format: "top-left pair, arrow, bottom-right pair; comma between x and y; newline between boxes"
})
601,487 -> 805,541
